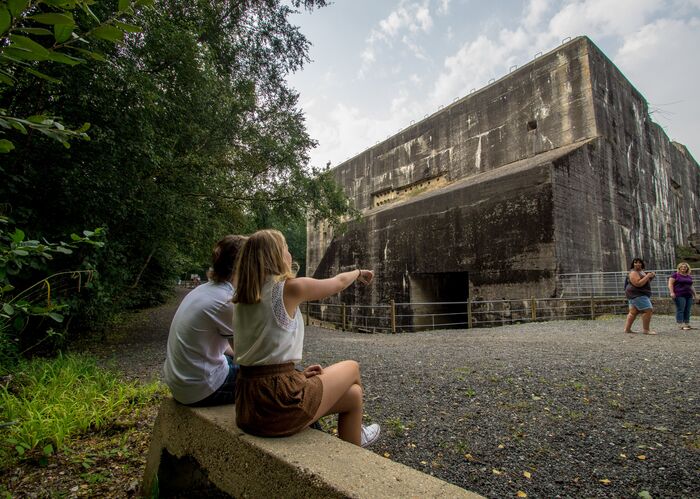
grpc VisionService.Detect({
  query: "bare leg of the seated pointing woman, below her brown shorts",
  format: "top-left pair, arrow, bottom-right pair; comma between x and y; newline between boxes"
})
315,360 -> 362,445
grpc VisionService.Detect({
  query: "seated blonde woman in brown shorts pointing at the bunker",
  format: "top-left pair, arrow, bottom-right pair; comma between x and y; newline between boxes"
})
233,230 -> 379,446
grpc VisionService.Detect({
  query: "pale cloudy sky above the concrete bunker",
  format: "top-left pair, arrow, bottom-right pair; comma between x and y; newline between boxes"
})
289,0 -> 700,167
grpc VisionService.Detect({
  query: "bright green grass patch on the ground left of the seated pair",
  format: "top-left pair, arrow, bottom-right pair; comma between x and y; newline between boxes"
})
0,355 -> 163,456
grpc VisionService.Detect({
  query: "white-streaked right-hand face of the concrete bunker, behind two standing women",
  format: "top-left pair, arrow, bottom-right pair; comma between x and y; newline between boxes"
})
553,39 -> 700,272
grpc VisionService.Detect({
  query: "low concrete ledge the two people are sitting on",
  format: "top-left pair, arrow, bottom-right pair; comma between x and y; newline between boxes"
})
142,398 -> 481,499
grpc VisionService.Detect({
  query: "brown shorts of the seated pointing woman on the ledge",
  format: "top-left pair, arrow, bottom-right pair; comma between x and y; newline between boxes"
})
236,362 -> 323,437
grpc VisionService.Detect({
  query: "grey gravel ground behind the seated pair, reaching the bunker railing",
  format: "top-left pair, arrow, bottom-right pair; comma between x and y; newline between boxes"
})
100,290 -> 700,498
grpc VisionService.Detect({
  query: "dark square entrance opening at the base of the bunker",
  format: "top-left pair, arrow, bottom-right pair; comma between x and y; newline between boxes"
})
406,272 -> 469,331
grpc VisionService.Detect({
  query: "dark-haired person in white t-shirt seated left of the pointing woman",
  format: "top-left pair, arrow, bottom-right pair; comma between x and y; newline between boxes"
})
163,235 -> 247,407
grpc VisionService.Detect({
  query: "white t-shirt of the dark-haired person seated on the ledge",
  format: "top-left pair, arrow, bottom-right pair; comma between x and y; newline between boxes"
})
163,281 -> 234,404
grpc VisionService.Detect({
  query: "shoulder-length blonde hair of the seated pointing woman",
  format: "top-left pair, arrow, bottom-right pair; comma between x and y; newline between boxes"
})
233,229 -> 294,304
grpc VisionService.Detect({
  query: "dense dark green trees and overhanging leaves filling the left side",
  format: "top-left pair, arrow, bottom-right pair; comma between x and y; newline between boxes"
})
0,0 -> 350,364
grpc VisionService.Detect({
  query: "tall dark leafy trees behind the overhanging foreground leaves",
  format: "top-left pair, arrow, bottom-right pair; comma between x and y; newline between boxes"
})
0,0 -> 348,334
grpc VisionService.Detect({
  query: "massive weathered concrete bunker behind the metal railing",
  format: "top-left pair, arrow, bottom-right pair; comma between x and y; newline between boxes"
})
307,37 -> 700,304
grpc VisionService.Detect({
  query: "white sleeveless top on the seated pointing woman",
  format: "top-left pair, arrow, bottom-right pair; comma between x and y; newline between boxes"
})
233,278 -> 304,366
